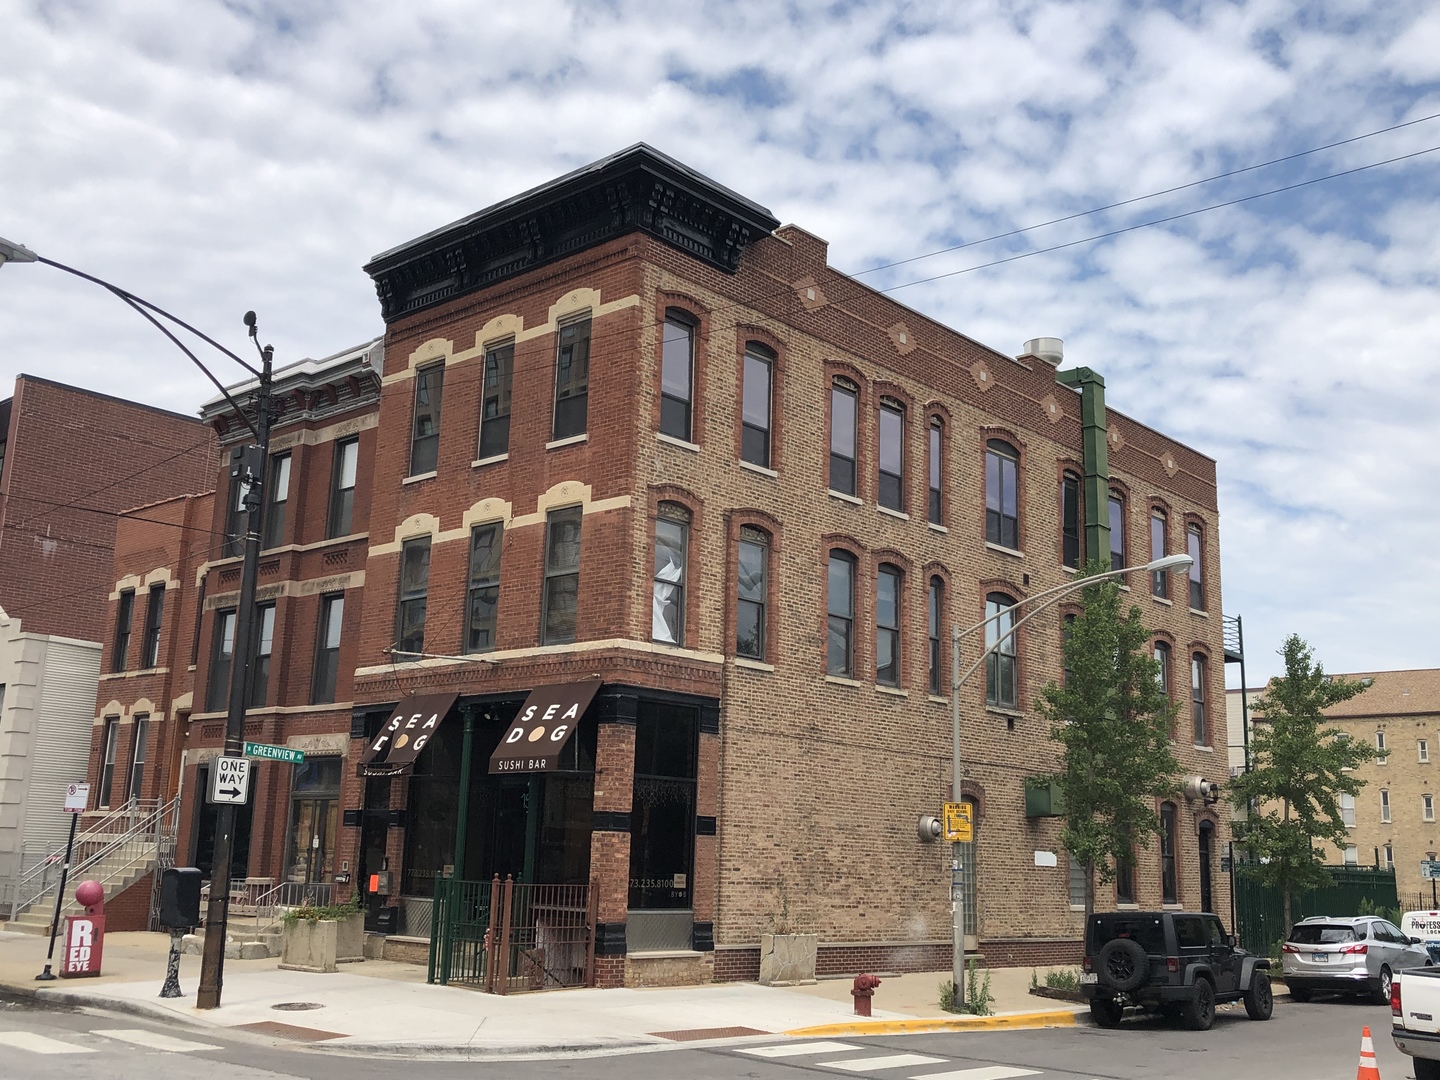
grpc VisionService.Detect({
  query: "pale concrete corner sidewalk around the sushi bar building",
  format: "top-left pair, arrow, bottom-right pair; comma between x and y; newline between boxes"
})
0,933 -> 1074,1057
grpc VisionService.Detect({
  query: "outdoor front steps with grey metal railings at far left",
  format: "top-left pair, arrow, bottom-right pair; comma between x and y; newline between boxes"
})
0,798 -> 180,933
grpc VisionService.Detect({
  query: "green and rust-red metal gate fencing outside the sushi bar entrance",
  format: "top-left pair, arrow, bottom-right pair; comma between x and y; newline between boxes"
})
426,877 -> 595,994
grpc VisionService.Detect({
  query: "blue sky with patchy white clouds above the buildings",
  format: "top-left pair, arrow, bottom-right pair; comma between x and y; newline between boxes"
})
0,0 -> 1440,680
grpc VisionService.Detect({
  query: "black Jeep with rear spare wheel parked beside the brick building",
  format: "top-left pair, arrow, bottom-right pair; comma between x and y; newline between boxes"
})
1080,912 -> 1274,1031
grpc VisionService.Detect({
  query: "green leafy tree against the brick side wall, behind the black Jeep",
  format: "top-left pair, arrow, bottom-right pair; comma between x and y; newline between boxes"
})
1037,562 -> 1179,926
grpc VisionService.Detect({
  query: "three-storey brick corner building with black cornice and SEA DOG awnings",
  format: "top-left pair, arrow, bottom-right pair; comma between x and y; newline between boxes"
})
331,145 -> 1228,985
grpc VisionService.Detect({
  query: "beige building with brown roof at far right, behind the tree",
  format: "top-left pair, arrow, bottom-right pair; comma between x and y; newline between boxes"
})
1225,668 -> 1440,910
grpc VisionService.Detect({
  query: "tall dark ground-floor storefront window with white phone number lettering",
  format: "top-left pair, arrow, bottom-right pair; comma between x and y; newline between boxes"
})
629,701 -> 700,909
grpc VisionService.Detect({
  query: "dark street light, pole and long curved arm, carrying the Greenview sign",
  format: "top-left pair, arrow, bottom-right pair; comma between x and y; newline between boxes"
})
0,236 -> 274,1008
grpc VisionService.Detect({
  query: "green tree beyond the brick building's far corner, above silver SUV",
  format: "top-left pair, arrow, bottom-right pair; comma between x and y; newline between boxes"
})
1230,634 -> 1375,930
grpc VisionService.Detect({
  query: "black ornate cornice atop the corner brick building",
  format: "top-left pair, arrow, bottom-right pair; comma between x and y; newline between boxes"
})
364,143 -> 779,323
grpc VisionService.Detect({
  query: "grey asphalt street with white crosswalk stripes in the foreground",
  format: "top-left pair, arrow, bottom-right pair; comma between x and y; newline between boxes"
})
0,1001 -> 1414,1080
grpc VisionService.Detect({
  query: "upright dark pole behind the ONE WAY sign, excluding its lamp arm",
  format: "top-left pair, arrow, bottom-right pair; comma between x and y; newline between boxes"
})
194,311 -> 274,1009
